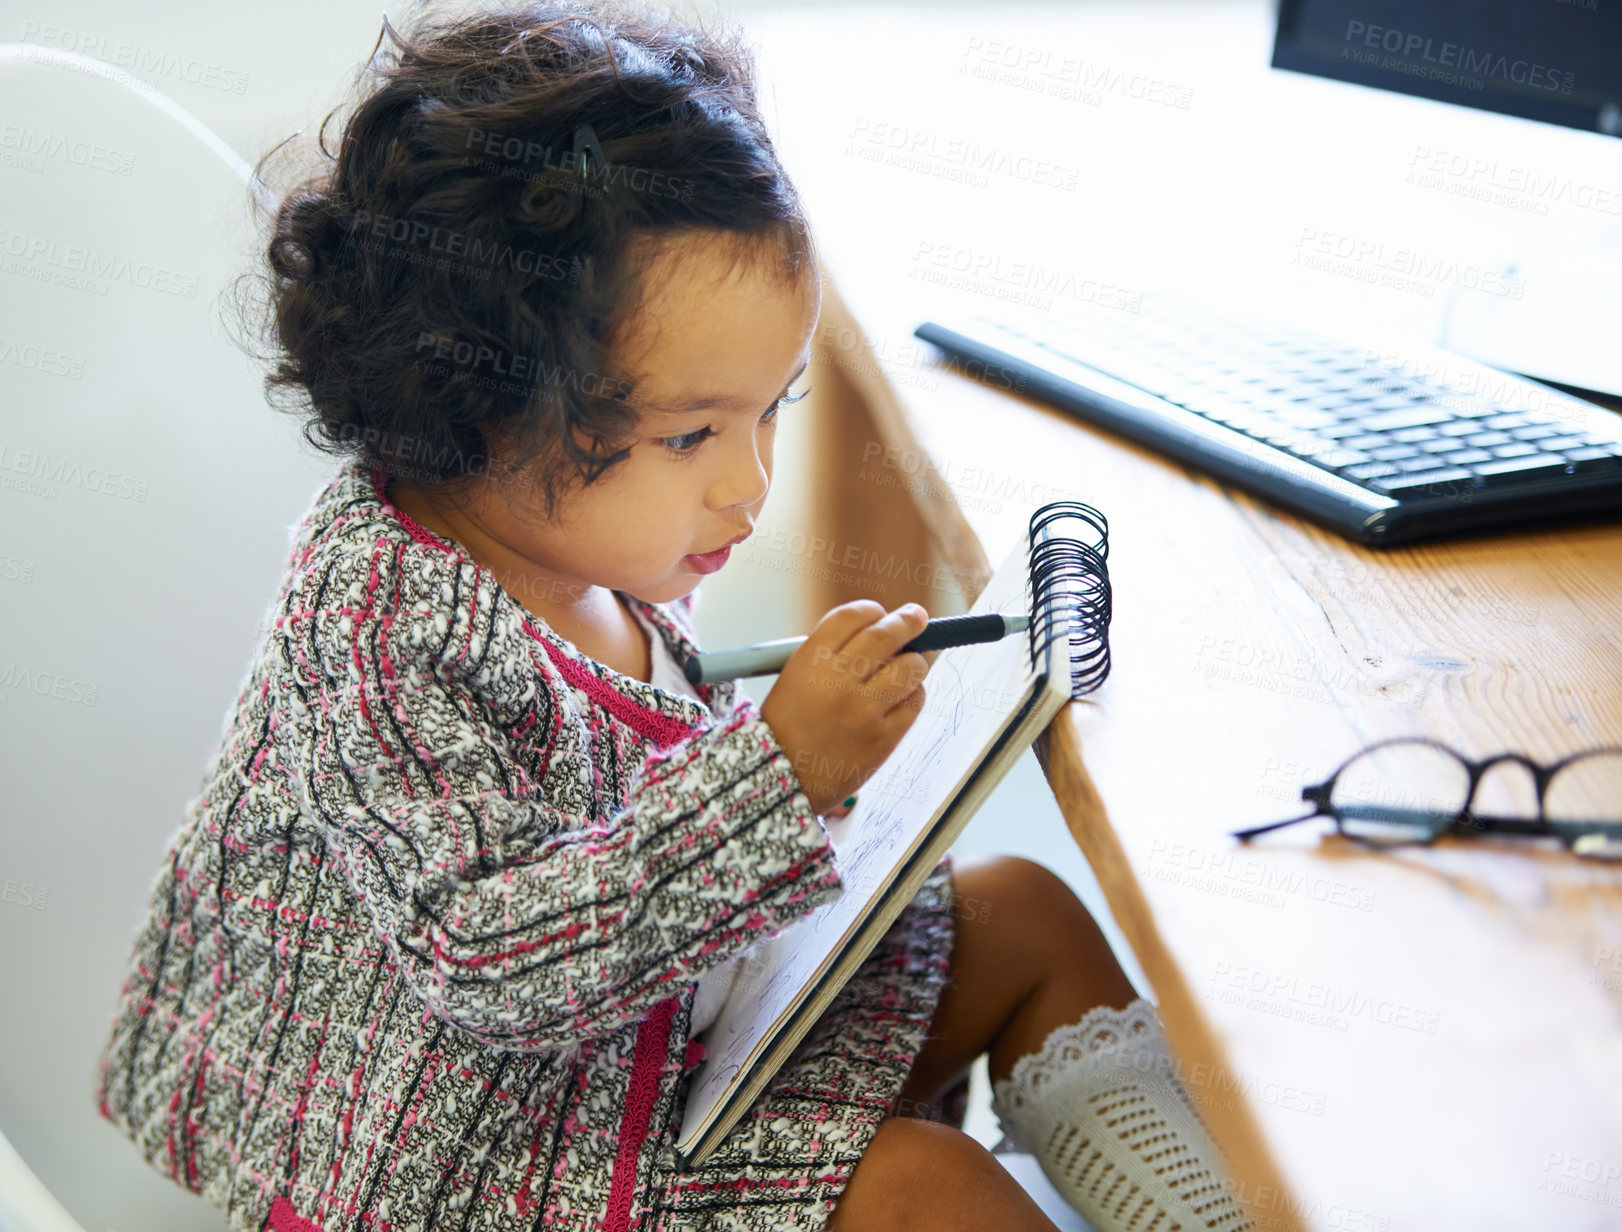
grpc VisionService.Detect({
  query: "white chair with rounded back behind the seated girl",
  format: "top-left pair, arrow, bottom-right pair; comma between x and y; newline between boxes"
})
0,45 -> 336,1232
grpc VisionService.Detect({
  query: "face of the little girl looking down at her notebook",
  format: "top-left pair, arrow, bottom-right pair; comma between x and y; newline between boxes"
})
447,231 -> 822,606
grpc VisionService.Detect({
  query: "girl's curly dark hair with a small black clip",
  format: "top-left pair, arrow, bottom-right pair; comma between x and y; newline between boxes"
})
235,0 -> 814,515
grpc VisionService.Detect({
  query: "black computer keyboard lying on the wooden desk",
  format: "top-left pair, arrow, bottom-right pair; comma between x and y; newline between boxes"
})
913,303 -> 1622,543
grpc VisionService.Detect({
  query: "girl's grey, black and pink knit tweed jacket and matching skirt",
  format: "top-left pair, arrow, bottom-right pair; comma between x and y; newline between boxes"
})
96,459 -> 962,1232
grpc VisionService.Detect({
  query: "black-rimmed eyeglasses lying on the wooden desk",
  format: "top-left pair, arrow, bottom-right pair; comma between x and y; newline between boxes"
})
1233,738 -> 1622,859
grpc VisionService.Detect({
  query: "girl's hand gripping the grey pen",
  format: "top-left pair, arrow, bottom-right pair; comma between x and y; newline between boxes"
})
761,598 -> 929,814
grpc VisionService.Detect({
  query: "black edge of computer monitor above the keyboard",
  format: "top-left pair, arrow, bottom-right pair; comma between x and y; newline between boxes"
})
1273,0 -> 1622,136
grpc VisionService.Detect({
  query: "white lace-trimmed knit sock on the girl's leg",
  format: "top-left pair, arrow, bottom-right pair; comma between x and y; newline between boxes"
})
991,999 -> 1249,1232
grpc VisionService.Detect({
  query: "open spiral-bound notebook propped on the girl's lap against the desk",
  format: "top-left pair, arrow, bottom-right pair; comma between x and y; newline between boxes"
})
676,501 -> 1109,1170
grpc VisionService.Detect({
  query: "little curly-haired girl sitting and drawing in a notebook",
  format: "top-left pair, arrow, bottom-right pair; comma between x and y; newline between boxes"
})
97,3 -> 1239,1232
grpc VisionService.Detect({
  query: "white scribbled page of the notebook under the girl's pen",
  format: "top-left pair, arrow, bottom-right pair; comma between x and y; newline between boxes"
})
681,538 -> 1032,1143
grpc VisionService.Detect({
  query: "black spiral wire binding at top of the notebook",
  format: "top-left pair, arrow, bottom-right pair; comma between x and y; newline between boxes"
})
1028,501 -> 1111,697
